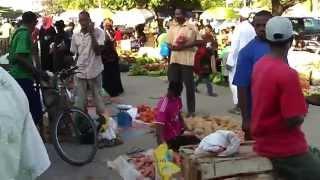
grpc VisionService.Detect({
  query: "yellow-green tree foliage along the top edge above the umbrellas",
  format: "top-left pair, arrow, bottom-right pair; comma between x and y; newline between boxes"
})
44,0 -> 306,15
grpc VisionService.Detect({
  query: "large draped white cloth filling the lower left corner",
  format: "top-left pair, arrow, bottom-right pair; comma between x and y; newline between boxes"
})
0,67 -> 50,180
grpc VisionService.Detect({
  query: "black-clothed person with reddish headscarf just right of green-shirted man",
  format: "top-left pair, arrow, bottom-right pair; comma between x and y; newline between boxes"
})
39,16 -> 56,72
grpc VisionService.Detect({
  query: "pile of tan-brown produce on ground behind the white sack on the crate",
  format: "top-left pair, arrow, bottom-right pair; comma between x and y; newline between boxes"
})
185,116 -> 243,139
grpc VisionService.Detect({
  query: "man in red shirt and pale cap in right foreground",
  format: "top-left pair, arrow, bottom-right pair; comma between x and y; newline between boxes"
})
251,16 -> 320,180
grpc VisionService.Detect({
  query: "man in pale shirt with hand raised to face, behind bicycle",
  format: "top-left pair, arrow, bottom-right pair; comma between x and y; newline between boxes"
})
70,11 -> 105,115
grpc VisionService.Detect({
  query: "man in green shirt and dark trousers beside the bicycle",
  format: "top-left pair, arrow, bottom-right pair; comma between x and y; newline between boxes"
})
8,11 -> 47,124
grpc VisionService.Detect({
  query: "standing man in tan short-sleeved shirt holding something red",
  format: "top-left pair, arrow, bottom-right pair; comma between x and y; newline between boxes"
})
168,8 -> 204,116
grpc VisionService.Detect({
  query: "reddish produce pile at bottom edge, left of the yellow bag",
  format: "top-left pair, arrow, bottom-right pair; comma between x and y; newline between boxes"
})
130,154 -> 155,179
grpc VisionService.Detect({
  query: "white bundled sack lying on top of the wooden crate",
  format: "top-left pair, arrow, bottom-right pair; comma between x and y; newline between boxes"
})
195,130 -> 240,156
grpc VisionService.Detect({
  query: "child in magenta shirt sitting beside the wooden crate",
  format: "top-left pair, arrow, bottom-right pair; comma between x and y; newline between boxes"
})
156,82 -> 200,151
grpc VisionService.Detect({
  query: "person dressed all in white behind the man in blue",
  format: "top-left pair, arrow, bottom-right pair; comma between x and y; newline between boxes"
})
226,8 -> 256,114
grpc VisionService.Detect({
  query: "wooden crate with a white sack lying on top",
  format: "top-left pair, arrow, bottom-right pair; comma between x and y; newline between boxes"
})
180,144 -> 273,180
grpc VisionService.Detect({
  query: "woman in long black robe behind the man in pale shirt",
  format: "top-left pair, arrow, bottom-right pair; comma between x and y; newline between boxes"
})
101,19 -> 123,100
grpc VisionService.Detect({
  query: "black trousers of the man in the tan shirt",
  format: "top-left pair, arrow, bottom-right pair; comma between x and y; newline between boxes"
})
168,63 -> 196,113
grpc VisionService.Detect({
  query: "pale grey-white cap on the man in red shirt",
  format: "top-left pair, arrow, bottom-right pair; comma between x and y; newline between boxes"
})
266,16 -> 293,42
